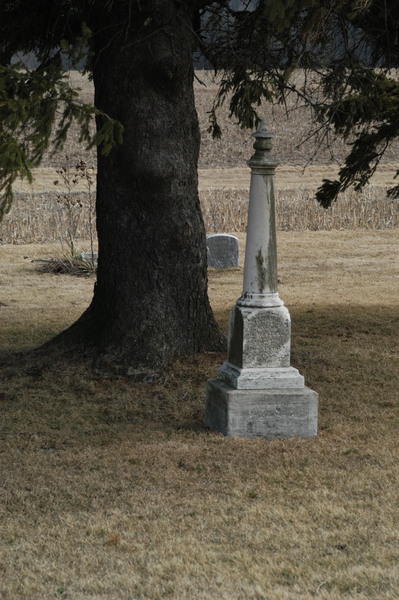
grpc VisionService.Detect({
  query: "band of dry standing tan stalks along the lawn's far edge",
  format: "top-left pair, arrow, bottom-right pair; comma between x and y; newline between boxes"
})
0,185 -> 399,250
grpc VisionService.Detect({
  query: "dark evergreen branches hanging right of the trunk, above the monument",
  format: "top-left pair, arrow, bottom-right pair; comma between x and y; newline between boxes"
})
204,0 -> 399,208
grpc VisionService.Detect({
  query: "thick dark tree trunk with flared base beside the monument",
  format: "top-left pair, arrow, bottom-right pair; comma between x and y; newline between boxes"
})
47,0 -> 224,378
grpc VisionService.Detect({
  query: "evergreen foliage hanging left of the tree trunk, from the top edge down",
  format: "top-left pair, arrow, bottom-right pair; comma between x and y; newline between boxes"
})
0,0 -> 123,220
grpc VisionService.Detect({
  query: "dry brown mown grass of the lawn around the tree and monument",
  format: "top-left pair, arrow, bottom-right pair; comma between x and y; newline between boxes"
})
0,230 -> 399,600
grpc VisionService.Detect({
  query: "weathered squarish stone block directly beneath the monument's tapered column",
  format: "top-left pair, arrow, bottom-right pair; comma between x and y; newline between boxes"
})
228,305 -> 291,368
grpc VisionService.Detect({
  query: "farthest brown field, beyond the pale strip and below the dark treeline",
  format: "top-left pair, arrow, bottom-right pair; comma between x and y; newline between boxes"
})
18,71 -> 399,169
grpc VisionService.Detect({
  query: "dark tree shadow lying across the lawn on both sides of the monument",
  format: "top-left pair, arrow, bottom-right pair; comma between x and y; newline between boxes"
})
0,306 -> 399,446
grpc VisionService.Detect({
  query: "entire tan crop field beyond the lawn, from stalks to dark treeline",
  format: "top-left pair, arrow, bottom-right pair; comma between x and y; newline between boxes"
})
0,72 -> 399,243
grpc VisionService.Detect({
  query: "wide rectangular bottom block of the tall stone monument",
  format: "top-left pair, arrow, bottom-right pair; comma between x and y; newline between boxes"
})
205,379 -> 318,439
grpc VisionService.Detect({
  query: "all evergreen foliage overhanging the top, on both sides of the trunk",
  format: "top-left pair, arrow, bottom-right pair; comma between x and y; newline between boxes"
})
0,0 -> 399,211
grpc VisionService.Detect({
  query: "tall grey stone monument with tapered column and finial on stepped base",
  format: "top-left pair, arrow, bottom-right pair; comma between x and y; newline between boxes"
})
205,121 -> 317,438
